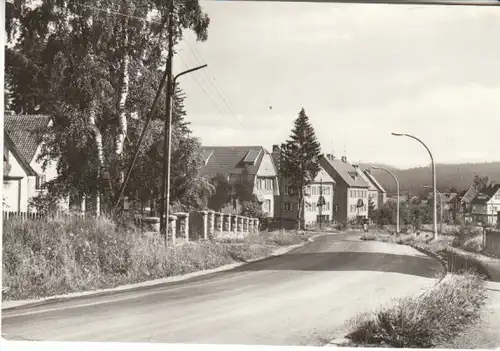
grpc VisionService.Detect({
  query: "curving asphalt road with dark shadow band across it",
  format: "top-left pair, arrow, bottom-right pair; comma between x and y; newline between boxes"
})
2,234 -> 441,345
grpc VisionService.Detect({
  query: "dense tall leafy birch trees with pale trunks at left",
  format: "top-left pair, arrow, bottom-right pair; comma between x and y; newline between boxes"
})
6,0 -> 209,212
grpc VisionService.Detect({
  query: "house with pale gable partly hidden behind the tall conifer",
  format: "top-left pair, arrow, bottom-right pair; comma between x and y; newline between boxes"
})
272,145 -> 335,226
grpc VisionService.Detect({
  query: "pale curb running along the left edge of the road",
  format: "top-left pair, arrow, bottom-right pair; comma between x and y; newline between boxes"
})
1,233 -> 329,312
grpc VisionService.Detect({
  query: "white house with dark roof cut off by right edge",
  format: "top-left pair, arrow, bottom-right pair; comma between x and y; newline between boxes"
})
470,183 -> 500,226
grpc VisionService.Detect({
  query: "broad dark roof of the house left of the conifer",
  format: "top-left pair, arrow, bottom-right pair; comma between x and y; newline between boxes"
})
201,146 -> 267,178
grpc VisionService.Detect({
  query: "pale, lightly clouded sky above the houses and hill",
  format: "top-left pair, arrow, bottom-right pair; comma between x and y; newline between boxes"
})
174,1 -> 500,168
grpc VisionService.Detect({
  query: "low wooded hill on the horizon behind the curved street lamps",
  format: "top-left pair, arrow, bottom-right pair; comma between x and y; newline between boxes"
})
360,162 -> 500,195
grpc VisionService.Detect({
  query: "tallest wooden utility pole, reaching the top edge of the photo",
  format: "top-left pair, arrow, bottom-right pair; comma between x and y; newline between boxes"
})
160,0 -> 178,243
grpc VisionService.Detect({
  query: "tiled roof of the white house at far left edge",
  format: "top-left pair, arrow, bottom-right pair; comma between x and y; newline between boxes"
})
4,113 -> 50,163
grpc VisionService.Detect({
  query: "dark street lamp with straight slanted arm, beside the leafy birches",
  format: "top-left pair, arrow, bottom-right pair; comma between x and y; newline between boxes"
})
160,65 -> 207,242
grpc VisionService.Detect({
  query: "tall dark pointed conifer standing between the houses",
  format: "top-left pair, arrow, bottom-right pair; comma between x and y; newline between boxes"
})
280,108 -> 321,229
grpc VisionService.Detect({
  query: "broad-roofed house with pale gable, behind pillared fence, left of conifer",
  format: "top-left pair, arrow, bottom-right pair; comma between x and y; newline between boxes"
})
200,146 -> 279,217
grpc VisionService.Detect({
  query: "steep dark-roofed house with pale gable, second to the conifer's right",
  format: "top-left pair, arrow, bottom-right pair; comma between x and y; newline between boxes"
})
320,154 -> 369,223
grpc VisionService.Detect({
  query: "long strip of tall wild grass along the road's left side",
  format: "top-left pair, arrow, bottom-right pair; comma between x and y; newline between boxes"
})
2,217 -> 307,300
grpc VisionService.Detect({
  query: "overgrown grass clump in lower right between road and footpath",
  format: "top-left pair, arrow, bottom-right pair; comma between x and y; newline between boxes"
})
347,273 -> 486,348
